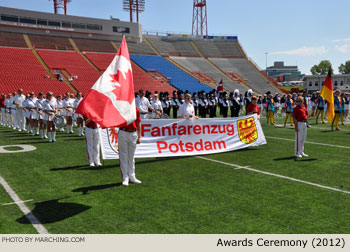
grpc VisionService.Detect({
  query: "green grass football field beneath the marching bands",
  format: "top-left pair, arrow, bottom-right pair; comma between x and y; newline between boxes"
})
0,113 -> 350,234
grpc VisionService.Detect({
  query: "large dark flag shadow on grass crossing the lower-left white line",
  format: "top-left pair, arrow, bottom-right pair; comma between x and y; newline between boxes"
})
16,199 -> 91,224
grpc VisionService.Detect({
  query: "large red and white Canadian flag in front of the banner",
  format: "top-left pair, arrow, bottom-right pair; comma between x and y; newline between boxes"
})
76,37 -> 136,128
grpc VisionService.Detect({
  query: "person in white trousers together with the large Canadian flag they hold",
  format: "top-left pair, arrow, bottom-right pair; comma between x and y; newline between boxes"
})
76,37 -> 141,186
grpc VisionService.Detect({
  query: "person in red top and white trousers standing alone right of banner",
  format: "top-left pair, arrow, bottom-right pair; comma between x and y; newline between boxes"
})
293,96 -> 311,158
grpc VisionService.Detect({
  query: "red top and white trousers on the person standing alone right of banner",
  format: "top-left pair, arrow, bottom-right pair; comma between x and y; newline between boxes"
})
293,105 -> 308,156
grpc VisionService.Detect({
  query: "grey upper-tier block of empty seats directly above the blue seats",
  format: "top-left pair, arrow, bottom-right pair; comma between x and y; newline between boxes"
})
146,36 -> 199,57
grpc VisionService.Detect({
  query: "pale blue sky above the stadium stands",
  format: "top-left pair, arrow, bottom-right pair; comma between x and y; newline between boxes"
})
0,0 -> 350,74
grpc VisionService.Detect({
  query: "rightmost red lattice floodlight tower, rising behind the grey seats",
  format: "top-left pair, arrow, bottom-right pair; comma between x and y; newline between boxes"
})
192,0 -> 208,37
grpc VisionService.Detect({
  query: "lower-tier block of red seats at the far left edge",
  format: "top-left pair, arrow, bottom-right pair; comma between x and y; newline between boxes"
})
0,47 -> 71,94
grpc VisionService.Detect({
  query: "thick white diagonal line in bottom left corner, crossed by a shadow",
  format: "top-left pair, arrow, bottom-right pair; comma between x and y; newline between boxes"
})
0,176 -> 49,234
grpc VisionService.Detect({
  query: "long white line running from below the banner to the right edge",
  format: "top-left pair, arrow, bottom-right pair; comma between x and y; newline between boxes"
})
196,156 -> 350,194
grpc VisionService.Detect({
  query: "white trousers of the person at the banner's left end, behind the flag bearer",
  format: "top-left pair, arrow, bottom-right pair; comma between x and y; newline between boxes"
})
85,127 -> 100,165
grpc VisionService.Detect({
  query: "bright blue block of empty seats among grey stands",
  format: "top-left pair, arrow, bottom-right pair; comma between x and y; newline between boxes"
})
130,54 -> 212,93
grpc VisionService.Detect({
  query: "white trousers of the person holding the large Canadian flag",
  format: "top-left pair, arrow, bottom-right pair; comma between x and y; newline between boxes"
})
118,130 -> 137,180
